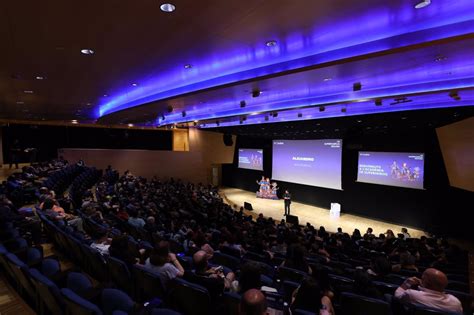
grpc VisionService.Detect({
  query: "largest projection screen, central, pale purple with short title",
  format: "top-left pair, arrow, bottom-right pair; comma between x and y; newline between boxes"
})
272,139 -> 342,189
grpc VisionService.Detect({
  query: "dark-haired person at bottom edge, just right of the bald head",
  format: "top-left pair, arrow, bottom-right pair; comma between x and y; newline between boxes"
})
291,277 -> 334,315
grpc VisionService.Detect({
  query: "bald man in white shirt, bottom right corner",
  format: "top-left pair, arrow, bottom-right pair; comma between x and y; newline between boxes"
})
395,268 -> 462,313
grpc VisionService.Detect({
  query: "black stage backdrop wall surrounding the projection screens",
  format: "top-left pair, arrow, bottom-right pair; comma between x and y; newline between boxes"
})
223,129 -> 474,239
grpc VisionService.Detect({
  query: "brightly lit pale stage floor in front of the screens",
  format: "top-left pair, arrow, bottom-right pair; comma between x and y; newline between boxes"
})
220,188 -> 425,237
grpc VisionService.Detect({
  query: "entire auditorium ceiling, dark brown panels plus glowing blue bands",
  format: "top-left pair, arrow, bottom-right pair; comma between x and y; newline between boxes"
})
0,0 -> 474,129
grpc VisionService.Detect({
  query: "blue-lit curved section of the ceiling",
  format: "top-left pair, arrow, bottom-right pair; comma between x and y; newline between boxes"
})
97,1 -> 474,126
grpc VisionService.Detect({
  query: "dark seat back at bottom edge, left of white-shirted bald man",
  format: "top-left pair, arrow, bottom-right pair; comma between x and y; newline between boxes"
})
341,292 -> 391,315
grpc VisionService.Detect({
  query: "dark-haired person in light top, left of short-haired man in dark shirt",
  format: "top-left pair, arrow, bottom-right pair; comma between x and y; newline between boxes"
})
145,241 -> 184,290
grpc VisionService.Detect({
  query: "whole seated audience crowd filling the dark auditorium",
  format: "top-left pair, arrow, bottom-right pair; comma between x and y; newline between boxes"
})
0,162 -> 467,314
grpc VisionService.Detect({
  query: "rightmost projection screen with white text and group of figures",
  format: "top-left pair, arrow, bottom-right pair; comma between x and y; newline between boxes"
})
357,152 -> 425,189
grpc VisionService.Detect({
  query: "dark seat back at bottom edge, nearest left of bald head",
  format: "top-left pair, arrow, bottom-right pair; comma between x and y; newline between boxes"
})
167,278 -> 211,315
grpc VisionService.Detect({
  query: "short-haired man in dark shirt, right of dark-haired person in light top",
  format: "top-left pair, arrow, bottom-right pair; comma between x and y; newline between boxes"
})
193,250 -> 235,297
